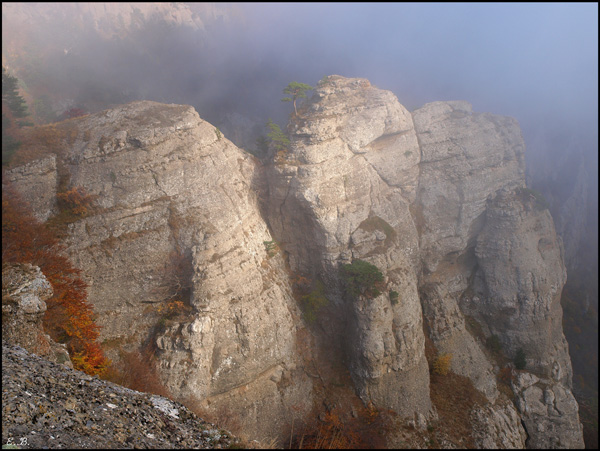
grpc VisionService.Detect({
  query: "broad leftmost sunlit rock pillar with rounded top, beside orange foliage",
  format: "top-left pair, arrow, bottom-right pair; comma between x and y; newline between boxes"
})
4,102 -> 311,437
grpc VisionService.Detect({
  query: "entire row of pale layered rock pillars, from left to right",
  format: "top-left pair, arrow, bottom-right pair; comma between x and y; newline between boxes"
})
4,76 -> 583,447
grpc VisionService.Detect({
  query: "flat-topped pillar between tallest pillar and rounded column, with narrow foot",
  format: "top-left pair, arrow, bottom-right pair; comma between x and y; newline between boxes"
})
413,101 -> 525,401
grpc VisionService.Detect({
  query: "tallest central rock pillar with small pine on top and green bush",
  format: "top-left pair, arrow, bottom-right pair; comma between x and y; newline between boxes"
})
268,76 -> 430,415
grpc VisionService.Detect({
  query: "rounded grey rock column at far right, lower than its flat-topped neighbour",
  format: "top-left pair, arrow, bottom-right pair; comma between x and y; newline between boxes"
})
463,191 -> 572,386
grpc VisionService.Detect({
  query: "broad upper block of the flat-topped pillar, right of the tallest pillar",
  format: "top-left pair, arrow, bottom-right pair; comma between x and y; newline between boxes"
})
413,101 -> 525,272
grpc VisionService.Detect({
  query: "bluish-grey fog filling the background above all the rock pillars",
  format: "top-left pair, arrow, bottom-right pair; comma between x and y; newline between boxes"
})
2,3 -> 598,259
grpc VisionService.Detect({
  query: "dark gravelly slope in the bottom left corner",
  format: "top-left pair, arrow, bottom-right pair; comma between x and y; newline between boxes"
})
2,342 -> 241,449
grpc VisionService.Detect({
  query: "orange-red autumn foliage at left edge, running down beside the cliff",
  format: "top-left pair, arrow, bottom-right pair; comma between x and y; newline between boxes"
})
2,186 -> 110,375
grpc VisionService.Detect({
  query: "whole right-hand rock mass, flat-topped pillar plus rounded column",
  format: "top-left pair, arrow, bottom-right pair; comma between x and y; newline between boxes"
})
413,102 -> 583,447
